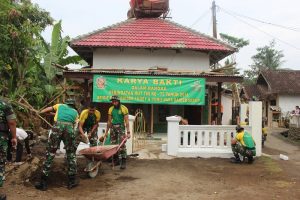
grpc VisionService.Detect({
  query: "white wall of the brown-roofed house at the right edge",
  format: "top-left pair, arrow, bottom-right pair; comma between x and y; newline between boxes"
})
277,95 -> 300,114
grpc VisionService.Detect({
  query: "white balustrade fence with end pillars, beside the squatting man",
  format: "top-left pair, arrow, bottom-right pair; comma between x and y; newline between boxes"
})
167,102 -> 262,158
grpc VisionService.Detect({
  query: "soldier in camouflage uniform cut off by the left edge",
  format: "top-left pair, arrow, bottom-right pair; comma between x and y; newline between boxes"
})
0,99 -> 17,200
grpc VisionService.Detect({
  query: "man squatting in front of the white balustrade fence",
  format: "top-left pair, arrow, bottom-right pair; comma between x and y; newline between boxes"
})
231,125 -> 256,163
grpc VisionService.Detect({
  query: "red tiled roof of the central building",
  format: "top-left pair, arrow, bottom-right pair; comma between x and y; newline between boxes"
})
71,18 -> 235,52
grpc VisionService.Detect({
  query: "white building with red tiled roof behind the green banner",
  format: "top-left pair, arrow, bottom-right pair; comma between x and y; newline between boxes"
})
64,18 -> 242,133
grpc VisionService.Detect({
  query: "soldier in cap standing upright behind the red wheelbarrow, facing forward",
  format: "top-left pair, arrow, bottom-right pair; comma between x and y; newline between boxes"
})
105,96 -> 130,169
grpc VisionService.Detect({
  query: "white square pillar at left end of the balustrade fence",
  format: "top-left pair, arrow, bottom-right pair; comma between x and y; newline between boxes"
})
167,116 -> 180,156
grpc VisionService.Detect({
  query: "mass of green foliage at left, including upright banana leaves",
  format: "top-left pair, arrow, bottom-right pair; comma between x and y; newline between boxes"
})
0,0 -> 81,111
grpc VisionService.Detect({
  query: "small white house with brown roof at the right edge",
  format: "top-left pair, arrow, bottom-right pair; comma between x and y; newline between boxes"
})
241,70 -> 300,126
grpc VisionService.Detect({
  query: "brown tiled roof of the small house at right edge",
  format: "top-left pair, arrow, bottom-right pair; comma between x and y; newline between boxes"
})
261,70 -> 300,94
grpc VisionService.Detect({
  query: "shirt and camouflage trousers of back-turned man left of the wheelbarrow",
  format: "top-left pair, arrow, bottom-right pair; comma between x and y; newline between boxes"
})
42,104 -> 78,177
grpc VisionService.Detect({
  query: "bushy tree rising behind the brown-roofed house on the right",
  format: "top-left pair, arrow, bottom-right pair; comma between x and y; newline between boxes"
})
244,40 -> 284,84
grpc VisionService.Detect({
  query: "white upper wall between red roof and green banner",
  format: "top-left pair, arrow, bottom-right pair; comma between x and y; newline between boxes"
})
93,48 -> 209,70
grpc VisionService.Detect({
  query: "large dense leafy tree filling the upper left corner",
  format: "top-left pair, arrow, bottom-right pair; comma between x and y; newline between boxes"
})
0,0 -> 52,103
